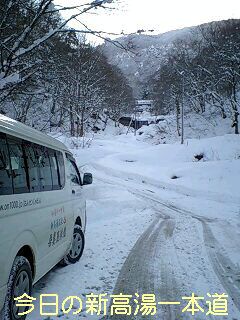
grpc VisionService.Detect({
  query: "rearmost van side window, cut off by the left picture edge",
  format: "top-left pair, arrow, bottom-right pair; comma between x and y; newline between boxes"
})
0,134 -> 13,195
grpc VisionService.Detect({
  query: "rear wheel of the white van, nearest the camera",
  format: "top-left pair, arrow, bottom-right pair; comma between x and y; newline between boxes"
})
3,256 -> 32,320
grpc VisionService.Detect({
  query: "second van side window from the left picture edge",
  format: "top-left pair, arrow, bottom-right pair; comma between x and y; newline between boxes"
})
8,138 -> 29,193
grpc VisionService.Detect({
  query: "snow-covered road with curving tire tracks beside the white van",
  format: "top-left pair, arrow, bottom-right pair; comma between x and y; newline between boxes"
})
27,137 -> 240,320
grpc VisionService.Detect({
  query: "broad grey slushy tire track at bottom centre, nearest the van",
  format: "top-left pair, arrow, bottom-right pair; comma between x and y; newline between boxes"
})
108,214 -> 186,320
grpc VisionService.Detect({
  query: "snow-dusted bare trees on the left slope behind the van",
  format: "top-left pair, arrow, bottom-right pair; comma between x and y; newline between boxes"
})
0,0 -> 133,136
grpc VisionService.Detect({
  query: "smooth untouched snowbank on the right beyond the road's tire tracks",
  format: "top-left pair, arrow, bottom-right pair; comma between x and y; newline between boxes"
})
94,135 -> 240,202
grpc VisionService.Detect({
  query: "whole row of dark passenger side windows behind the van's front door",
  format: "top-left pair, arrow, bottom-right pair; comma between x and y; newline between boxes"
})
0,132 -> 65,195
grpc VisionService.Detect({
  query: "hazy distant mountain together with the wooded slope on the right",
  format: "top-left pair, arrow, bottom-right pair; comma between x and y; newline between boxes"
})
102,19 -> 240,135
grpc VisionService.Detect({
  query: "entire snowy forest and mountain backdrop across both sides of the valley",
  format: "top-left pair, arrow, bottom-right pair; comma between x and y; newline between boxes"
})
0,0 -> 240,137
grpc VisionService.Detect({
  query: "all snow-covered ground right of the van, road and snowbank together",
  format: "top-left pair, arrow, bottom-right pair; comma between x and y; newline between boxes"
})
27,132 -> 240,320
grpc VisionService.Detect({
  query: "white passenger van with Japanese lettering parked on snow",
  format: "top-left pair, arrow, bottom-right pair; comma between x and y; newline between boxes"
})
0,115 -> 92,320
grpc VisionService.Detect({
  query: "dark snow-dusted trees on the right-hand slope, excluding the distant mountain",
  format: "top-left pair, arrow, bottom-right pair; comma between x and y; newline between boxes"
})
148,20 -> 240,135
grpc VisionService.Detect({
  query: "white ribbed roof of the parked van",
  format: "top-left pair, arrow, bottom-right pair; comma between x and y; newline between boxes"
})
0,114 -> 70,153
